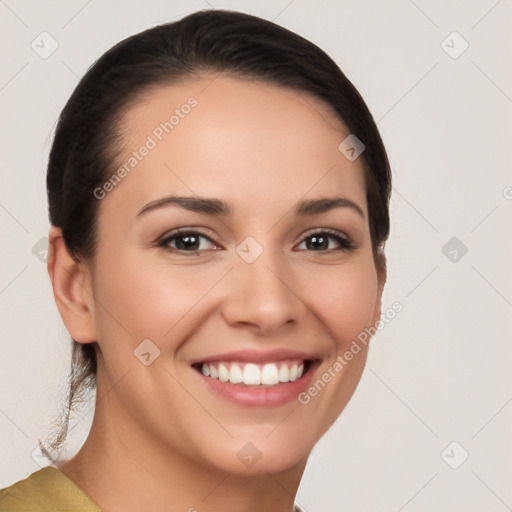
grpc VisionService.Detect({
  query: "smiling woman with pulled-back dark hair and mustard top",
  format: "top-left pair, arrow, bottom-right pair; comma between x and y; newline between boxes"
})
0,10 -> 391,512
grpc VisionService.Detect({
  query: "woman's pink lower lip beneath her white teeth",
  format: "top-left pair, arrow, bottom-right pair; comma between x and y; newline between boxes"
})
193,364 -> 317,407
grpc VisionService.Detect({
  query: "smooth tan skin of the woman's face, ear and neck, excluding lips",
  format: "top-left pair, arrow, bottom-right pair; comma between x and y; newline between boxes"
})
48,75 -> 386,512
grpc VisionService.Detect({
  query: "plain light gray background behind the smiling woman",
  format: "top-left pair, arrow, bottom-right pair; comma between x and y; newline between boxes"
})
0,0 -> 512,512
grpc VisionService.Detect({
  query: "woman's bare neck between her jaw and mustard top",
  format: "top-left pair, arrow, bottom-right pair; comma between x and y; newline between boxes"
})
56,380 -> 306,512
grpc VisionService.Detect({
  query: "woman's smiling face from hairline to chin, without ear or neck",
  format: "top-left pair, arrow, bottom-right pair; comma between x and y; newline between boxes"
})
83,76 -> 385,474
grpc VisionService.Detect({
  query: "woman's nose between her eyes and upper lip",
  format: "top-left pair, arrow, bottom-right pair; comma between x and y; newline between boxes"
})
222,251 -> 307,335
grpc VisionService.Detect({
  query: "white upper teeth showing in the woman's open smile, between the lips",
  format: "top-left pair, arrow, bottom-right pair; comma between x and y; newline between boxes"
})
192,359 -> 314,388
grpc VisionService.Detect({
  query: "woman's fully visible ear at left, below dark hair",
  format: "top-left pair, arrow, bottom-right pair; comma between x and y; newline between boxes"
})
47,226 -> 96,343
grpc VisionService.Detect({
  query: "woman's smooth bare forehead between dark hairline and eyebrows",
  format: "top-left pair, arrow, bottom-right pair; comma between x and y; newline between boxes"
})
105,75 -> 366,218
